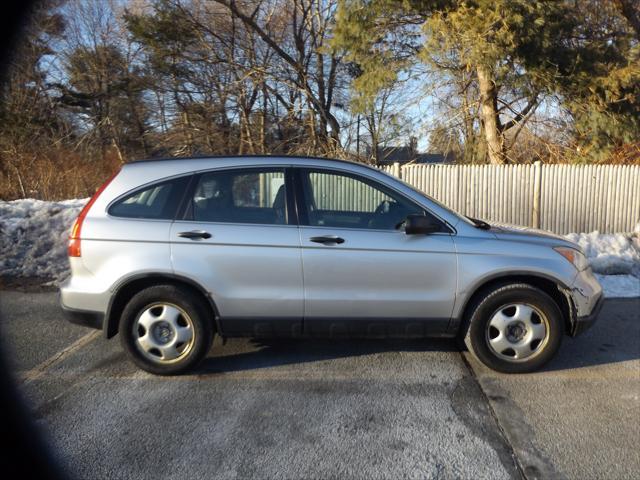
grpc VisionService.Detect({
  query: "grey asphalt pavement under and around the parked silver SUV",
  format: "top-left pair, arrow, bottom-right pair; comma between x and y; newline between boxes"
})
0,291 -> 640,479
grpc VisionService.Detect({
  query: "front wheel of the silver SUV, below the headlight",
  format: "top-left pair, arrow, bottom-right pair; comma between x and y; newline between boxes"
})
464,284 -> 563,373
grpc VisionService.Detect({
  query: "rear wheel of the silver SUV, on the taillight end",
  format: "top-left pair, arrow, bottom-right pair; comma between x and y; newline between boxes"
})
119,285 -> 213,375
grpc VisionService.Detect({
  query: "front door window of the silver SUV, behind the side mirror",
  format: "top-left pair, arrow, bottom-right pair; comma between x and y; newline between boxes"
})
301,170 -> 427,230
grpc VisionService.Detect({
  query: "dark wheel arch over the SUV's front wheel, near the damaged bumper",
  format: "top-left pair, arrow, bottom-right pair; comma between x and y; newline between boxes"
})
452,272 -> 575,337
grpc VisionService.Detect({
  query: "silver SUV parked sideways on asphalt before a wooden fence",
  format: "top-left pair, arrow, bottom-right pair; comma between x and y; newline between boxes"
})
61,157 -> 603,374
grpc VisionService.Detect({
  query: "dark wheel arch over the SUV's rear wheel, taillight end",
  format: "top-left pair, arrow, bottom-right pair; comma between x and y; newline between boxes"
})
102,273 -> 221,338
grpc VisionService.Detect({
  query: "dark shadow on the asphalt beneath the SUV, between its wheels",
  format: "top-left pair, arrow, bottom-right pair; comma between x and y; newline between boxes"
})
192,338 -> 458,375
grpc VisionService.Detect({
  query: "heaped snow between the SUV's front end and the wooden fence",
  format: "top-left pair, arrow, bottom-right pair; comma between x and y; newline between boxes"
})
566,228 -> 640,278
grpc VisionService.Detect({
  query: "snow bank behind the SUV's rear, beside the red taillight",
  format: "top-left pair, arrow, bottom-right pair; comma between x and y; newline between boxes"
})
0,198 -> 89,279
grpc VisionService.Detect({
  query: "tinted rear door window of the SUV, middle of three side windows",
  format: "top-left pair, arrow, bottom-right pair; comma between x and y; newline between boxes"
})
190,169 -> 287,225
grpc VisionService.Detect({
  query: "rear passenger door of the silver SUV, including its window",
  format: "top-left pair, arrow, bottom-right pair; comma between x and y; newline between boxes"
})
171,167 -> 303,336
